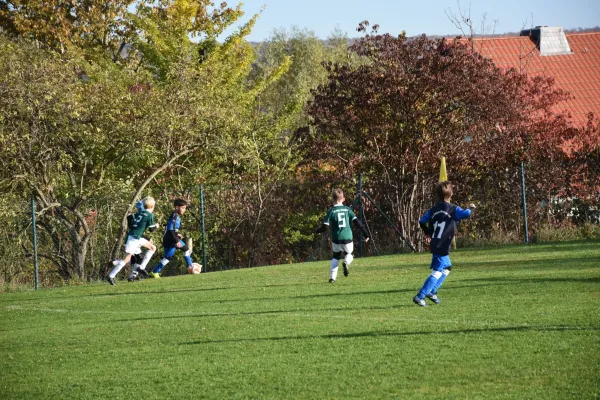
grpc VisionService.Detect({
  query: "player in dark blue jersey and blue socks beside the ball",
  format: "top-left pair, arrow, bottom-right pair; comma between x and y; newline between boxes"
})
150,199 -> 193,278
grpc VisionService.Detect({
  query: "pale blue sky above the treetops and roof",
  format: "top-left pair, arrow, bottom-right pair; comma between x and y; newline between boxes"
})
220,0 -> 600,42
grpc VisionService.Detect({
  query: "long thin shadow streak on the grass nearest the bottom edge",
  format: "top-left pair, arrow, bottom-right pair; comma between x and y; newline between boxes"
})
179,325 -> 600,346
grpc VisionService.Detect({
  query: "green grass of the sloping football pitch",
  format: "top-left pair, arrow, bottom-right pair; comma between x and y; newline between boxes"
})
0,242 -> 600,399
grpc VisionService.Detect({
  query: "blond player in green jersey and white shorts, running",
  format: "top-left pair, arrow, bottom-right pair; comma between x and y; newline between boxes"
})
106,197 -> 158,285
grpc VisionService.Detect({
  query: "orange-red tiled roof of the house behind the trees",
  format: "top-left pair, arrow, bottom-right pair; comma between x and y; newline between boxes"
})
476,32 -> 600,125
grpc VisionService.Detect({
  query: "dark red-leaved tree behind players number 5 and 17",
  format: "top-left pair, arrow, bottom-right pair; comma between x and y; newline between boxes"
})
307,22 -> 572,247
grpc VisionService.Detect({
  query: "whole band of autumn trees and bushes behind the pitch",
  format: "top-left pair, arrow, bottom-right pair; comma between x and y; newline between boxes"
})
0,7 -> 600,283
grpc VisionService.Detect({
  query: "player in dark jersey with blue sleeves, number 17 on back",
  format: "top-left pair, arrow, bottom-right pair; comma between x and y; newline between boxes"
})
413,181 -> 475,307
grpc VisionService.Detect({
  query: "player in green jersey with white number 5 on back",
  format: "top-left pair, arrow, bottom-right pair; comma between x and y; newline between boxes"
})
317,189 -> 369,283
